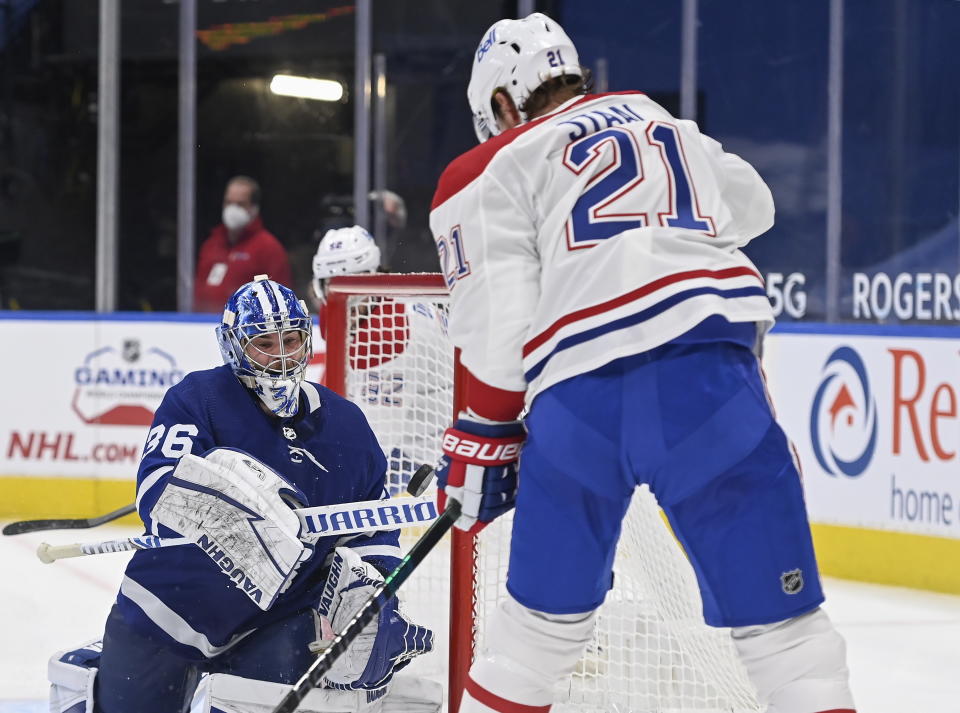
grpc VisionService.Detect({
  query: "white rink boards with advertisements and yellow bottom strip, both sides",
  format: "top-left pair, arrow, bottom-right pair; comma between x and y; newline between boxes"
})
0,312 -> 960,593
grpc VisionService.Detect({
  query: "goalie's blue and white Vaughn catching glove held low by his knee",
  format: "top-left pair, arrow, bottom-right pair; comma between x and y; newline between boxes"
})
310,547 -> 433,690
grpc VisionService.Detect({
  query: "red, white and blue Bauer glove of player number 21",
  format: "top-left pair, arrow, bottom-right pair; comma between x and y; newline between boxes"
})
437,418 -> 526,533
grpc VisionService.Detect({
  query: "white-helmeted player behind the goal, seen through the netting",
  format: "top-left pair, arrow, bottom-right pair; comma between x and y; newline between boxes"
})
313,225 -> 453,495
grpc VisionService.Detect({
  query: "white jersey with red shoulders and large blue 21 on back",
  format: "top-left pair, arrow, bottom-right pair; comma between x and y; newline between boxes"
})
430,92 -> 774,405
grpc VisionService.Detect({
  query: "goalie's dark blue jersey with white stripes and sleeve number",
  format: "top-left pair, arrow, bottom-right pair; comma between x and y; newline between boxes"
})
117,366 -> 400,660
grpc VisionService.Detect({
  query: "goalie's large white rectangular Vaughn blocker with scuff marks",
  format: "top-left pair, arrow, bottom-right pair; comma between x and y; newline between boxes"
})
150,448 -> 313,611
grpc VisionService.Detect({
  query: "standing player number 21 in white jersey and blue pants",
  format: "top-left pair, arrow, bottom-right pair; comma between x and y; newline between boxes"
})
430,13 -> 854,713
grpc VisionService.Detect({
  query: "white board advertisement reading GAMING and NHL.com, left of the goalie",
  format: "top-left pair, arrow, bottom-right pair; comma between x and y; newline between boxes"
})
0,312 -> 323,480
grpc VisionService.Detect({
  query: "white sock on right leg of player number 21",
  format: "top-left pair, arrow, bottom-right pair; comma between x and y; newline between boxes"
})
731,608 -> 855,713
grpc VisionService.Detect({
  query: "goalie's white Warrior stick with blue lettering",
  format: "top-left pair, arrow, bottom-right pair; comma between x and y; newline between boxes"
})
37,492 -> 437,564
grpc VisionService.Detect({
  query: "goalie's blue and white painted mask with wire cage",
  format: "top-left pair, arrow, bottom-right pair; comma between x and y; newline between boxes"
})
217,275 -> 312,418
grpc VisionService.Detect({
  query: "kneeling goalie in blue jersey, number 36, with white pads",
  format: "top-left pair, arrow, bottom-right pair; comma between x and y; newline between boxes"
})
50,275 -> 437,713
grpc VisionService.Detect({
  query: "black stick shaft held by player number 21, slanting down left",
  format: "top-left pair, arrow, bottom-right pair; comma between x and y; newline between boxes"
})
272,466 -> 460,713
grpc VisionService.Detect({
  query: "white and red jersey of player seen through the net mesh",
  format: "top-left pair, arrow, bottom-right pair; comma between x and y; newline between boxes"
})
347,299 -> 453,495
